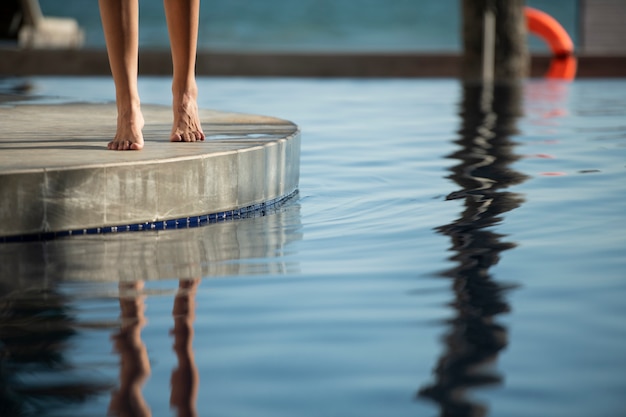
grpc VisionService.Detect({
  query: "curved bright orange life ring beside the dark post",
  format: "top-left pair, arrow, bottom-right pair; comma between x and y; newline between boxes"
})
524,7 -> 576,80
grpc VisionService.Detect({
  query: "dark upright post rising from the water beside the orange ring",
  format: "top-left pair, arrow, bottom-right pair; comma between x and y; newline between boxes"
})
461,0 -> 529,83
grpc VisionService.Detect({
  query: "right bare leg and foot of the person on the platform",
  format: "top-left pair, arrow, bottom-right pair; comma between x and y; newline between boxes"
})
163,0 -> 204,142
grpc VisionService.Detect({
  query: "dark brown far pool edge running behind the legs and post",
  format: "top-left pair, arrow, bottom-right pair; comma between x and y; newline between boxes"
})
0,47 -> 626,78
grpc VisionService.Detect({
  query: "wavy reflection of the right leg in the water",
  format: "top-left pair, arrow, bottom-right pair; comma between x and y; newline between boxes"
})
170,279 -> 200,417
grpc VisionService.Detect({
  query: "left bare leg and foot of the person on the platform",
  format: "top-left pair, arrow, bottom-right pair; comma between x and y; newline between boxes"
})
99,0 -> 144,150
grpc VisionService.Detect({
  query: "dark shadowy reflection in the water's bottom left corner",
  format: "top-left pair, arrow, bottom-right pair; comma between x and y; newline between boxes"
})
0,286 -> 110,417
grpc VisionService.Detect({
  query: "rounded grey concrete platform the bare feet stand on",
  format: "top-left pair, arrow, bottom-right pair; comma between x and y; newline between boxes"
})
0,103 -> 300,242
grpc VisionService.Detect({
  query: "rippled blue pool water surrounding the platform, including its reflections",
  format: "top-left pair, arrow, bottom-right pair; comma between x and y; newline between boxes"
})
0,78 -> 626,416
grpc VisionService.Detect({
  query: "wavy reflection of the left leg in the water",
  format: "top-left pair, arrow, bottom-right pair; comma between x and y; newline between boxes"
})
109,281 -> 151,416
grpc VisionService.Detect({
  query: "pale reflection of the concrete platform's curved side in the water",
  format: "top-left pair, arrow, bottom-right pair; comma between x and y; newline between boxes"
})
0,202 -> 302,282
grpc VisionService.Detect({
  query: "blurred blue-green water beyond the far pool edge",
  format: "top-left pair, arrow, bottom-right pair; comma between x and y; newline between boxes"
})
40,0 -> 579,52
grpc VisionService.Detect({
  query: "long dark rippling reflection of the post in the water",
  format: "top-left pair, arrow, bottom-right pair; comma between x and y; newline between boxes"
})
418,85 -> 525,416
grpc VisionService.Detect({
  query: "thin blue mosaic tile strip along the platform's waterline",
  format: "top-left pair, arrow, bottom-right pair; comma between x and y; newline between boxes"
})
0,190 -> 298,243
